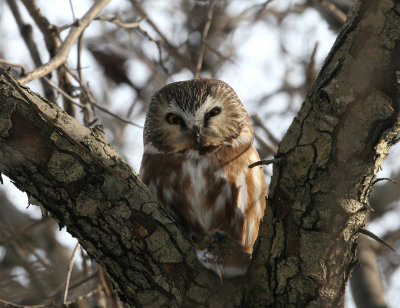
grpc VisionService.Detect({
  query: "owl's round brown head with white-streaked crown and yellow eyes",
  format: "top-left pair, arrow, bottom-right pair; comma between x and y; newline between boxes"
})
144,79 -> 253,154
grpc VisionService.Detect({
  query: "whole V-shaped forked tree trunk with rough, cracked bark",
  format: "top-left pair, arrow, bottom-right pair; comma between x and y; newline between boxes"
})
0,0 -> 400,307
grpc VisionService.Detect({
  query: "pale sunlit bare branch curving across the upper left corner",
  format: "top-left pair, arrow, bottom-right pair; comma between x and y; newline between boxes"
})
18,0 -> 110,84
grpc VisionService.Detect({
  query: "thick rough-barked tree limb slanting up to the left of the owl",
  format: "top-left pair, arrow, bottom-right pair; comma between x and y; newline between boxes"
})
0,71 -> 242,307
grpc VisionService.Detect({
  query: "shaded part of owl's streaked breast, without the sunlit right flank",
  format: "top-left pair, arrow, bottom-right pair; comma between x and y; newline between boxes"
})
140,148 -> 243,238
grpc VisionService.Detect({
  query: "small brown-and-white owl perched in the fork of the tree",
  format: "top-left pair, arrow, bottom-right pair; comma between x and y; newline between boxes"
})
139,79 -> 267,277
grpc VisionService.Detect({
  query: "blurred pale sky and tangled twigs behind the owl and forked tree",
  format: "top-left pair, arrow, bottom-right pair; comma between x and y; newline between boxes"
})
0,0 -> 400,307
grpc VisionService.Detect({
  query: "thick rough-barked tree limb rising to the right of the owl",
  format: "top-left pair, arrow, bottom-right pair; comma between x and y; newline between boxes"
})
252,0 -> 400,307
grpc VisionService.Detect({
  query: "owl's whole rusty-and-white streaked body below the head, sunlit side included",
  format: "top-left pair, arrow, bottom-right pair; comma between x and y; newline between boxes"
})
140,141 -> 265,254
